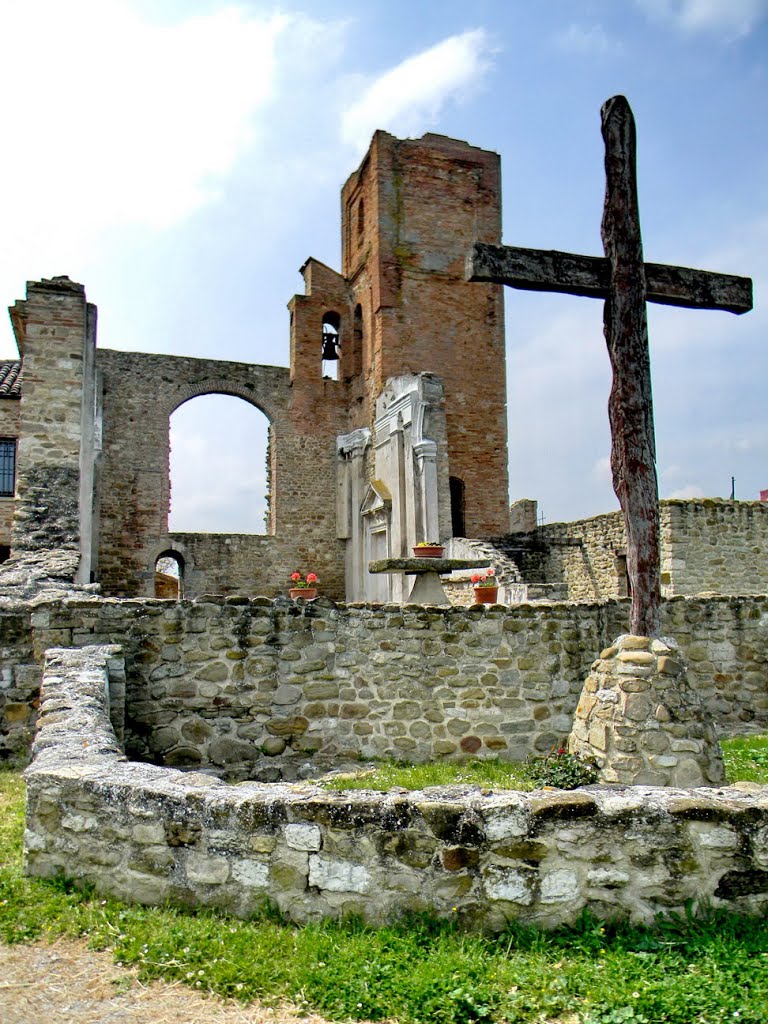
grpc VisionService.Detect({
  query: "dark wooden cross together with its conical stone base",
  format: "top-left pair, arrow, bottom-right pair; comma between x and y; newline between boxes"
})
468,96 -> 752,786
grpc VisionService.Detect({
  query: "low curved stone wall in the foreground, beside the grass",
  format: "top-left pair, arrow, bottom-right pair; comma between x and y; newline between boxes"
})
25,646 -> 768,930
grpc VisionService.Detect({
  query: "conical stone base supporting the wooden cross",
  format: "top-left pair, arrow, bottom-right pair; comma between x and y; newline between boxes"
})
568,635 -> 725,787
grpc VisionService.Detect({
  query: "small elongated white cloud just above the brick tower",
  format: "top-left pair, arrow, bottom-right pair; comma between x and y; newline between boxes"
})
341,29 -> 490,150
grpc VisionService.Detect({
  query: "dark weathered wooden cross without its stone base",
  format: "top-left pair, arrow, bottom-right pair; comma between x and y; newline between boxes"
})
467,96 -> 752,636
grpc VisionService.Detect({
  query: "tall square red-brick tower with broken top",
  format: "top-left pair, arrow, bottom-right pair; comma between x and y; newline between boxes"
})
340,131 -> 509,537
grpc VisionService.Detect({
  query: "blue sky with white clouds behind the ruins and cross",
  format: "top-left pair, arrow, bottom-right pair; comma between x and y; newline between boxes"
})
0,0 -> 768,531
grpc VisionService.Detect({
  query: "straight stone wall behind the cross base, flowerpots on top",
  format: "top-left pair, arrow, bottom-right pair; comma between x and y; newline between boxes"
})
0,597 -> 768,781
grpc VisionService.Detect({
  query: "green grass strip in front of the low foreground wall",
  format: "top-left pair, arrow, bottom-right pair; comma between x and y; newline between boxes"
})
0,772 -> 768,1024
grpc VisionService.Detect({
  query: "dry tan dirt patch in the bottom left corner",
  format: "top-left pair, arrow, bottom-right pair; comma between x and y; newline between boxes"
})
0,939 -> 335,1024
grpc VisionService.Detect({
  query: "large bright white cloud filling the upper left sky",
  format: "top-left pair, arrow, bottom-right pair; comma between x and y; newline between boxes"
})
0,0 -> 301,287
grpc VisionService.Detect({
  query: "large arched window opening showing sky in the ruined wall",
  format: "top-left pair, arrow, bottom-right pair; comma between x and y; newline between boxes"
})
169,394 -> 270,534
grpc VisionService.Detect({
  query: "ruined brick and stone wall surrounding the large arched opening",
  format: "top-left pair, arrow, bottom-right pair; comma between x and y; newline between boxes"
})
98,350 -> 344,597
